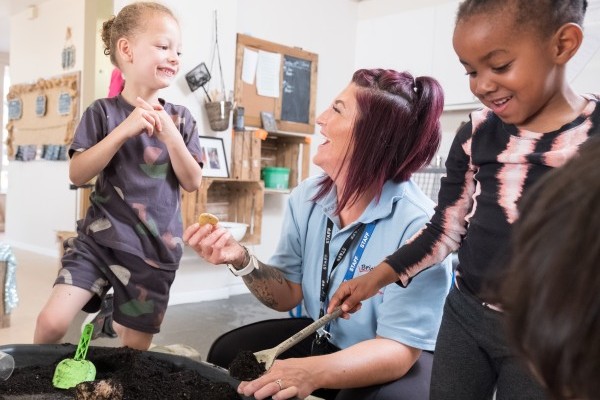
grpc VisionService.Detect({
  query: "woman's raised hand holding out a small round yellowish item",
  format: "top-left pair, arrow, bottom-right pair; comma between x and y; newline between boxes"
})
183,223 -> 246,267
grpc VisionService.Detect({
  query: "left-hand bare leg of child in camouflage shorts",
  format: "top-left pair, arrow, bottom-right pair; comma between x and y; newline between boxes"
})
33,284 -> 93,344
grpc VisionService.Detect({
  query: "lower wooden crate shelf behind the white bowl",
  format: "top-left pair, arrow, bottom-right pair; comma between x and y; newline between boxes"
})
181,178 -> 264,244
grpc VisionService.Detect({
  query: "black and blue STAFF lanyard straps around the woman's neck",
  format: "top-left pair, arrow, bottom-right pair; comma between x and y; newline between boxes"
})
319,219 -> 376,318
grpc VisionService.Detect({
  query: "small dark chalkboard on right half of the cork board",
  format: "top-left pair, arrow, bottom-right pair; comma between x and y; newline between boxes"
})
281,56 -> 311,124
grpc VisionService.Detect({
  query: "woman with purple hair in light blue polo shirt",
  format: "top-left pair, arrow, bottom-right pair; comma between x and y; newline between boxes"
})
183,69 -> 451,400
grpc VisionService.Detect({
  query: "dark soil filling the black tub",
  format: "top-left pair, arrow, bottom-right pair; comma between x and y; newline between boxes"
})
0,347 -> 240,400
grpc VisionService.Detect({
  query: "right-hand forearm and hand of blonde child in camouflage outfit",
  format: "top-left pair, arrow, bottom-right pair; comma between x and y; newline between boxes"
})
137,97 -> 202,192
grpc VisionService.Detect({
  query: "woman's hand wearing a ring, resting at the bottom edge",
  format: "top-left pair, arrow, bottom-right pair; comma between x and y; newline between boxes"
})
238,357 -> 319,400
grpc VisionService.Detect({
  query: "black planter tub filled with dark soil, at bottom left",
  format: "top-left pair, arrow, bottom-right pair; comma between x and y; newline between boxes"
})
0,344 -> 254,400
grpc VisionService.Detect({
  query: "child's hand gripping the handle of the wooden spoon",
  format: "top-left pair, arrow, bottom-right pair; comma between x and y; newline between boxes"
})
327,262 -> 398,319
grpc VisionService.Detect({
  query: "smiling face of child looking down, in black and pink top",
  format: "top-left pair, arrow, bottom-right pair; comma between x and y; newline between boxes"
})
453,13 -> 564,125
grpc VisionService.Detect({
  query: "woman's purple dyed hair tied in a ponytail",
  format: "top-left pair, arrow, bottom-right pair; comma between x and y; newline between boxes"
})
314,69 -> 444,214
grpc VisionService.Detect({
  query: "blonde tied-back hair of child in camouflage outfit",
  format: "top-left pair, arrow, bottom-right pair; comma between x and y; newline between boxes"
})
102,1 -> 177,67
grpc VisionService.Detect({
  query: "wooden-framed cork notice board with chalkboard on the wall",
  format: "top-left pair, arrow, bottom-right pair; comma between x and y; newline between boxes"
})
234,34 -> 318,133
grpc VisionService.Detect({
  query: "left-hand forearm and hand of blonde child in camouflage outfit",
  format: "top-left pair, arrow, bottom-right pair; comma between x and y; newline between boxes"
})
69,107 -> 160,186
